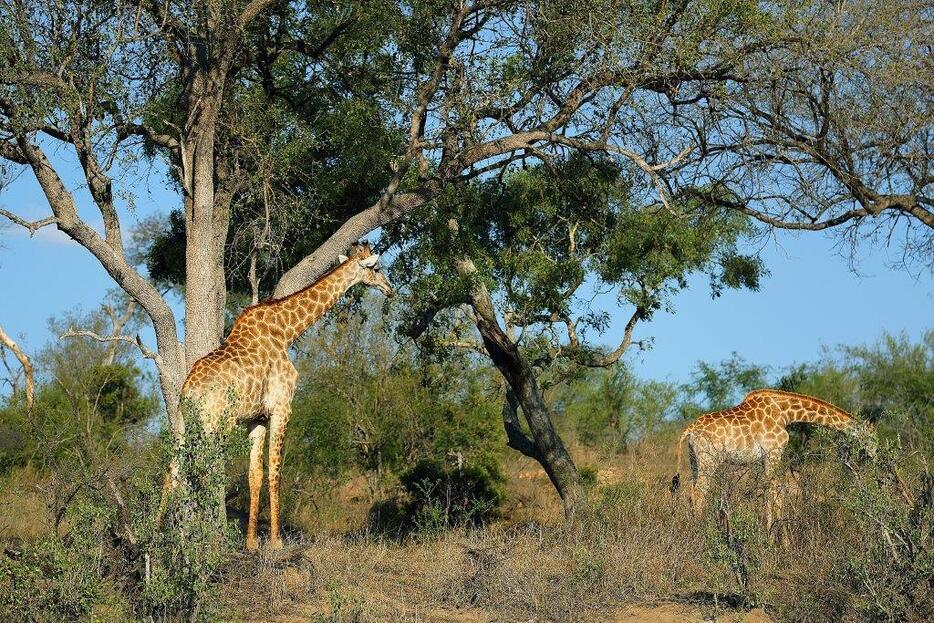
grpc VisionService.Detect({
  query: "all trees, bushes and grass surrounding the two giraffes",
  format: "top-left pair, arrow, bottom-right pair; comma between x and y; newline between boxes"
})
0,0 -> 934,621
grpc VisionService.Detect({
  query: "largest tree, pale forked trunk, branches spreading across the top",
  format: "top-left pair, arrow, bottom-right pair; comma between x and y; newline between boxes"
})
0,0 -> 934,444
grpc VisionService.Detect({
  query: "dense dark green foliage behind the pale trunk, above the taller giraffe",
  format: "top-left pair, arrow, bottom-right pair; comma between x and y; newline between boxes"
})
137,0 -> 408,300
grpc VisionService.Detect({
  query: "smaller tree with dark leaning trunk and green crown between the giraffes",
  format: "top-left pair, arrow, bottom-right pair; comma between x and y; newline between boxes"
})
390,155 -> 762,515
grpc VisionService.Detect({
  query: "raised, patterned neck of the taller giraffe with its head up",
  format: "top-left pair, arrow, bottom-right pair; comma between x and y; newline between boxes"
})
269,258 -> 359,345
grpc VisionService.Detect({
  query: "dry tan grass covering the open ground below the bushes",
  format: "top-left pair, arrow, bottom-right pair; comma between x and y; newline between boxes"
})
0,428 -> 920,623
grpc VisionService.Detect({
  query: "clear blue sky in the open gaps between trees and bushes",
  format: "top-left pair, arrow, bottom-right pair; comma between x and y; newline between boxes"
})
0,154 -> 934,381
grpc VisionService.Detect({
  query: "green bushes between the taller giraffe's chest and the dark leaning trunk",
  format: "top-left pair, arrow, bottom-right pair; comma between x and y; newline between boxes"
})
285,300 -> 503,490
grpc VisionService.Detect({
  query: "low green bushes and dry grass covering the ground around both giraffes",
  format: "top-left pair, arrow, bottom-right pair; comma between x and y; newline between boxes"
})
0,300 -> 934,621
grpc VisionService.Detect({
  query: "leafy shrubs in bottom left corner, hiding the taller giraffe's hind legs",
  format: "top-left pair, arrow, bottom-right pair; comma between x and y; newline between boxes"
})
0,398 -> 245,621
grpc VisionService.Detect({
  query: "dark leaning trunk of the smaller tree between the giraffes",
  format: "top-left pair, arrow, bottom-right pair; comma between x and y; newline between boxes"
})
457,259 -> 586,519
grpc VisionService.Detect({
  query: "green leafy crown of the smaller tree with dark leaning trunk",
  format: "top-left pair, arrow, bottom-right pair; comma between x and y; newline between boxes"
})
391,155 -> 763,351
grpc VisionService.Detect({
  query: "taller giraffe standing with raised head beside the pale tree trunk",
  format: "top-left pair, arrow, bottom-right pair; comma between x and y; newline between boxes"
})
160,243 -> 393,550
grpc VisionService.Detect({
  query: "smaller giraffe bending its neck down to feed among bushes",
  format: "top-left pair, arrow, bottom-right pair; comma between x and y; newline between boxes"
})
671,389 -> 862,530
